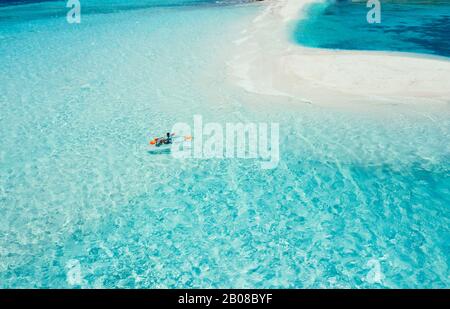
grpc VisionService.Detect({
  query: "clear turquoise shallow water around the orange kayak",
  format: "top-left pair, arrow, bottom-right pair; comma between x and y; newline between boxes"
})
0,2 -> 450,288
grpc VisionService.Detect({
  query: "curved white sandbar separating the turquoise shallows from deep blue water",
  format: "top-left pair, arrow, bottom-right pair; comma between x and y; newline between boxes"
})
230,0 -> 450,105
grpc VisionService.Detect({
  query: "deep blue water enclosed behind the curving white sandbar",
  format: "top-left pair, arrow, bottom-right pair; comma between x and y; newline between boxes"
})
294,1 -> 450,57
